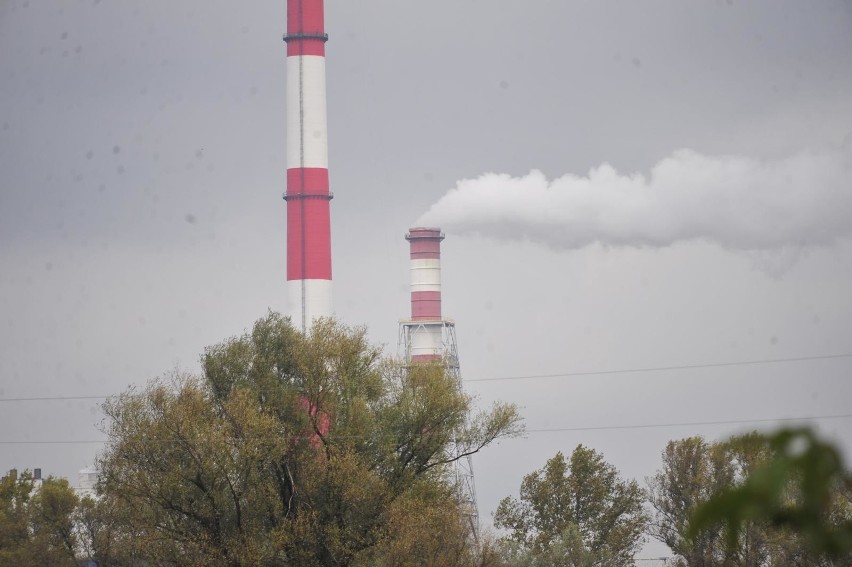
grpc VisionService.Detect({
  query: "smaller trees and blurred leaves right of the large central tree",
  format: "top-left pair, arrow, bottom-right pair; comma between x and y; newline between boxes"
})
494,430 -> 852,567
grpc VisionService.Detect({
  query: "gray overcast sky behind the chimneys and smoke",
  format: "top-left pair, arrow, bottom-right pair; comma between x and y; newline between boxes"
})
0,0 -> 852,554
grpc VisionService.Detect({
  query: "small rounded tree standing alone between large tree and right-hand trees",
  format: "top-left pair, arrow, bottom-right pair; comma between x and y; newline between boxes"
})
494,445 -> 647,567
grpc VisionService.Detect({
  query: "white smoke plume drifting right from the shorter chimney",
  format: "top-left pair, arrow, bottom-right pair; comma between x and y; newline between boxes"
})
418,147 -> 852,251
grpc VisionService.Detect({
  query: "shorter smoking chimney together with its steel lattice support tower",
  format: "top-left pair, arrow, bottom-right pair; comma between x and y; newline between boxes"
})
399,227 -> 479,541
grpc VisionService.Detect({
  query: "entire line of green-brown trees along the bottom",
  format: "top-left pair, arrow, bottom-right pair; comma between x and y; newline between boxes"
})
0,313 -> 852,567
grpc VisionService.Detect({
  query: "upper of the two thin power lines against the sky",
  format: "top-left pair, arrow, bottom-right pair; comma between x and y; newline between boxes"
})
0,353 -> 852,403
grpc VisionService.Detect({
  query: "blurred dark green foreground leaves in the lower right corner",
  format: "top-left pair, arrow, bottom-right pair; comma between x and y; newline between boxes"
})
686,429 -> 852,563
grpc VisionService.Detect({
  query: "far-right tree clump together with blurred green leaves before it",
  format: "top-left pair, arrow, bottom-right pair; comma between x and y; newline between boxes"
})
648,430 -> 852,567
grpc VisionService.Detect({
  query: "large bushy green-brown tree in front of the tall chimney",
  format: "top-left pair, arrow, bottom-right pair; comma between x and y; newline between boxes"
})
99,313 -> 520,566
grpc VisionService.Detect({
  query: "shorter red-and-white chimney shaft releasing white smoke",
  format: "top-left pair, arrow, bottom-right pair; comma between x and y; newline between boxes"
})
405,227 -> 444,362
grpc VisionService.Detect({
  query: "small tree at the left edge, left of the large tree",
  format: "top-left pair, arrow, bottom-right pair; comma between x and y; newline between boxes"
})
0,471 -> 78,566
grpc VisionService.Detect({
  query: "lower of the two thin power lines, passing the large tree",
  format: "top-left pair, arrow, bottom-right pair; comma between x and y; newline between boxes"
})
0,413 -> 852,445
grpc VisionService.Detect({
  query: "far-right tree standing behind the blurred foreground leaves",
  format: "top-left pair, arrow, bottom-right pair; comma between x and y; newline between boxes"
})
648,432 -> 852,567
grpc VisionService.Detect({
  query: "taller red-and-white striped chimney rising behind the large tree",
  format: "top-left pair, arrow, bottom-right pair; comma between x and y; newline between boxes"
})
284,0 -> 333,332
